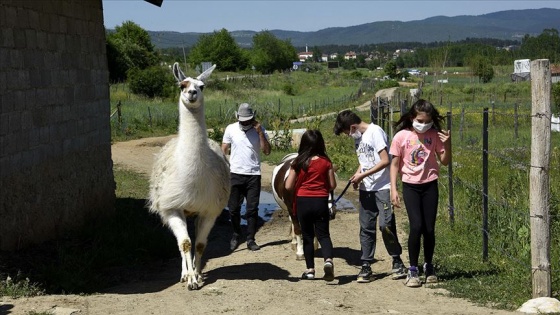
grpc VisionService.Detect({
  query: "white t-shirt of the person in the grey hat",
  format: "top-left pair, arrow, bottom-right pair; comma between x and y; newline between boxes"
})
222,122 -> 268,175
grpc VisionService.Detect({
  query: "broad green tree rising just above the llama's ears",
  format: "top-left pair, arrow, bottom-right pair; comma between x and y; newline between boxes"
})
188,28 -> 248,71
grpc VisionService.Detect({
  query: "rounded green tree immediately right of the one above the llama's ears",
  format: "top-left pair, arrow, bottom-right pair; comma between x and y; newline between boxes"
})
251,31 -> 298,73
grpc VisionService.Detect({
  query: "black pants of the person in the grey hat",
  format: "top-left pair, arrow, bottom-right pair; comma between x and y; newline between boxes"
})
228,173 -> 261,241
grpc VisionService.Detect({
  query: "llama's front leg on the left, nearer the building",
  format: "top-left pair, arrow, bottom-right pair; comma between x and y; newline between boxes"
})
167,211 -> 194,282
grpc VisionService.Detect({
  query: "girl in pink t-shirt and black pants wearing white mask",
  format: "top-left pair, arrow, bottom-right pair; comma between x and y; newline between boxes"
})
389,99 -> 451,287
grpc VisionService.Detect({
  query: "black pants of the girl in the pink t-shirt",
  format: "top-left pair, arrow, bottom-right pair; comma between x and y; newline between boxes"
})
403,180 -> 439,266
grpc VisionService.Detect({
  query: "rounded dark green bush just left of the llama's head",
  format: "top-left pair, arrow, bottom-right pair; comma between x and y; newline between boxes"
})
128,66 -> 174,98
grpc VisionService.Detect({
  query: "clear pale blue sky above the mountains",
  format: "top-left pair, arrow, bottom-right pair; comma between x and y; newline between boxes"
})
103,0 -> 560,33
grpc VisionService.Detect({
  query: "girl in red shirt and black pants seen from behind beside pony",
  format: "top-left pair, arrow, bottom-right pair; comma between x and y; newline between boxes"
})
285,130 -> 336,281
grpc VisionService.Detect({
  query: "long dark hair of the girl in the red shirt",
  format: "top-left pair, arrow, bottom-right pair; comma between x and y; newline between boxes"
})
292,130 -> 330,174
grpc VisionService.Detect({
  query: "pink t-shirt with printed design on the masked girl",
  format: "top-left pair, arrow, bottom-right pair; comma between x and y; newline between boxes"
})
389,128 -> 444,184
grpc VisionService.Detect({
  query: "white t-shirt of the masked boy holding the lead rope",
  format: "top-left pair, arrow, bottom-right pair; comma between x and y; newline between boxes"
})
356,123 -> 391,191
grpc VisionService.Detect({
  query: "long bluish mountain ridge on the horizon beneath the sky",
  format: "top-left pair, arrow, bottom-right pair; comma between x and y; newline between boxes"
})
148,8 -> 560,48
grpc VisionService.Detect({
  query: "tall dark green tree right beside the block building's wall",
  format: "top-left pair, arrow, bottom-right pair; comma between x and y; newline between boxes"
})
107,21 -> 160,81
